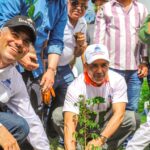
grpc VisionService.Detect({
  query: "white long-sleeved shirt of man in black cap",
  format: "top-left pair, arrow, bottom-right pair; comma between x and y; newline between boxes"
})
0,65 -> 50,150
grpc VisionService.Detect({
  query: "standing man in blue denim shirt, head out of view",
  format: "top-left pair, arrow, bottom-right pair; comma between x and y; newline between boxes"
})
0,0 -> 67,108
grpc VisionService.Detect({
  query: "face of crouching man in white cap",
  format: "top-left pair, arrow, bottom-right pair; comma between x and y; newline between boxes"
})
85,59 -> 109,84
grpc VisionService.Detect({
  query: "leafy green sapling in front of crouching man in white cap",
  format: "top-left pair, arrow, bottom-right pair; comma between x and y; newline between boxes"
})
73,95 -> 106,150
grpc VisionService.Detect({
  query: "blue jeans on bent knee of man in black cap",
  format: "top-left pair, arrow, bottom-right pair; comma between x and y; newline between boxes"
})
0,112 -> 29,144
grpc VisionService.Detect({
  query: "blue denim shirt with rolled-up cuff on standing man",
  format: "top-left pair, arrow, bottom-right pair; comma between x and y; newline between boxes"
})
0,0 -> 67,78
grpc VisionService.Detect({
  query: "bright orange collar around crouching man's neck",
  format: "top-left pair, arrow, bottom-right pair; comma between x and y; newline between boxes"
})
84,72 -> 109,87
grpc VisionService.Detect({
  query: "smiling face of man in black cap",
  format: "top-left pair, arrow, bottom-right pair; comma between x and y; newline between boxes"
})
0,27 -> 31,64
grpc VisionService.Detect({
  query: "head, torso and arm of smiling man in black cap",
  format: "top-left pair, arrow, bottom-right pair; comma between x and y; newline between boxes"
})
0,16 -> 50,150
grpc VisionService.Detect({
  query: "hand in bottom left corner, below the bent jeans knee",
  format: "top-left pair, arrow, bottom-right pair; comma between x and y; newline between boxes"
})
0,126 -> 20,150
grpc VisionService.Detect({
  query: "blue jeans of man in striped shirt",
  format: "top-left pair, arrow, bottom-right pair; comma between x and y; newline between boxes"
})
110,68 -> 143,112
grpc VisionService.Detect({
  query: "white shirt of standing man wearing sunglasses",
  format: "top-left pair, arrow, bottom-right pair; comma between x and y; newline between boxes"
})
58,17 -> 87,66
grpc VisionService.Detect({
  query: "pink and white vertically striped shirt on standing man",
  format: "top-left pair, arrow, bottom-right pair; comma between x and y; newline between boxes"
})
94,0 -> 148,70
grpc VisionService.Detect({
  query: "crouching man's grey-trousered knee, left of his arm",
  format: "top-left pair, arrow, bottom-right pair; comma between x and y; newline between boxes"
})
52,107 -> 63,126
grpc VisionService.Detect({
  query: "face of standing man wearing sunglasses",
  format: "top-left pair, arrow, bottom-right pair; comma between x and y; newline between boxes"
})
68,0 -> 88,21
